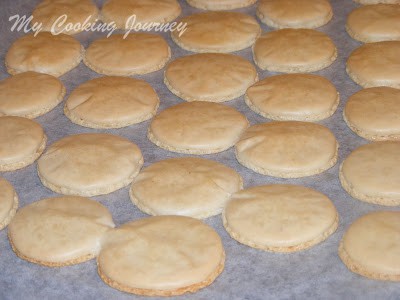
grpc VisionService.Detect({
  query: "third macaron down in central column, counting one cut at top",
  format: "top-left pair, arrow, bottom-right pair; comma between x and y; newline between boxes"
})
164,53 -> 258,102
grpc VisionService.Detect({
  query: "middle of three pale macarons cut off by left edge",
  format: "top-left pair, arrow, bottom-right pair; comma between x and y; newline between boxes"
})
0,116 -> 47,172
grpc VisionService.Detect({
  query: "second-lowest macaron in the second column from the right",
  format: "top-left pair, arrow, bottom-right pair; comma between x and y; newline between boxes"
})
235,121 -> 339,178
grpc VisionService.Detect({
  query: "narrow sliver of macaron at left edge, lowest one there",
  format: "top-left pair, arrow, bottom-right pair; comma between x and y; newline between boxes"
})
0,177 -> 18,230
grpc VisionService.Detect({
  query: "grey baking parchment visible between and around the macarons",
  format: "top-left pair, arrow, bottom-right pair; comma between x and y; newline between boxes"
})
0,0 -> 400,299
